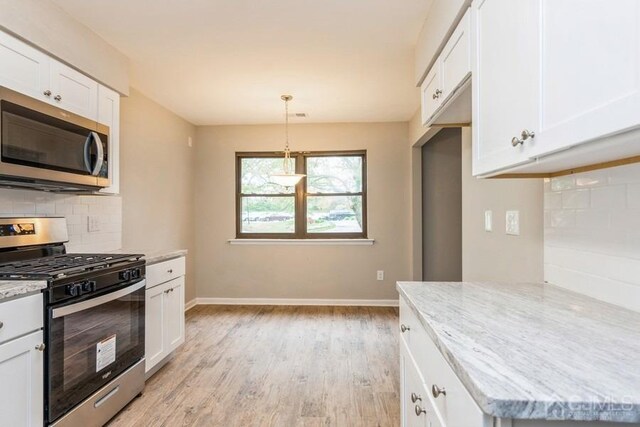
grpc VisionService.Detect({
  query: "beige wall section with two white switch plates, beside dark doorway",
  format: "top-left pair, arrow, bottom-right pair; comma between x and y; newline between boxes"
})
462,127 -> 544,282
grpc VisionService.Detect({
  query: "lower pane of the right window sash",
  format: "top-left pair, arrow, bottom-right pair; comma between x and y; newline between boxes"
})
307,196 -> 362,233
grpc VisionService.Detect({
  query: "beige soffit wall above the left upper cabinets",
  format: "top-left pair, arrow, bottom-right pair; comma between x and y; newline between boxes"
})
0,0 -> 129,95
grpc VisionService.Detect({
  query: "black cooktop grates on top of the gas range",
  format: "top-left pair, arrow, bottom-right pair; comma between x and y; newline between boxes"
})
0,254 -> 140,278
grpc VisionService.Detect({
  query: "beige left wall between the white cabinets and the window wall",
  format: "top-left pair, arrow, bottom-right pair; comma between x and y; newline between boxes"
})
120,89 -> 196,301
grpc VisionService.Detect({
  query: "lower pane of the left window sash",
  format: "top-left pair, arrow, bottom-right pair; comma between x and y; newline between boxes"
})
240,196 -> 296,233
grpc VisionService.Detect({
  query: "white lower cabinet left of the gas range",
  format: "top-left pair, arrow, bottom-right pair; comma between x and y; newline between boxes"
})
0,294 -> 44,427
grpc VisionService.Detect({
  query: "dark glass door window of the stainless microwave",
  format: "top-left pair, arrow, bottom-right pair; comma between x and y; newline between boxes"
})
2,101 -> 107,176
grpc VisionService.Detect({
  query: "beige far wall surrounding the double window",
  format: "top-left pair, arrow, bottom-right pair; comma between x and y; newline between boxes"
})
195,123 -> 411,299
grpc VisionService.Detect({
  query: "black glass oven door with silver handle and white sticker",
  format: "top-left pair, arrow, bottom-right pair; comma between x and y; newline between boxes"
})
46,280 -> 145,422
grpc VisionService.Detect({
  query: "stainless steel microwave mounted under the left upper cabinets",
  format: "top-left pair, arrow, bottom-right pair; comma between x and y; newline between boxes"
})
0,87 -> 111,192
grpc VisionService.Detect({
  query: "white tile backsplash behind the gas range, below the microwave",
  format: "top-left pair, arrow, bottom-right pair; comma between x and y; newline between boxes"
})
0,189 -> 122,252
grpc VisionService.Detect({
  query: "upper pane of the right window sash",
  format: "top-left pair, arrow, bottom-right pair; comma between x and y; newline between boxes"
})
307,156 -> 362,193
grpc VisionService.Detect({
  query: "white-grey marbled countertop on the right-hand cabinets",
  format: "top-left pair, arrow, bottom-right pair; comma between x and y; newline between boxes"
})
397,282 -> 640,422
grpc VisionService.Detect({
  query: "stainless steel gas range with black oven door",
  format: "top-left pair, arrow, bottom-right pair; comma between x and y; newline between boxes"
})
0,218 -> 145,427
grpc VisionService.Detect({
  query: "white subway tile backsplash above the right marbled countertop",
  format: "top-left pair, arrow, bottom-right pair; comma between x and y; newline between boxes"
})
544,164 -> 640,311
